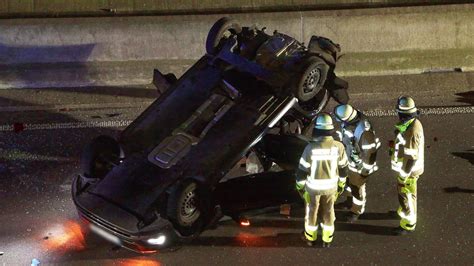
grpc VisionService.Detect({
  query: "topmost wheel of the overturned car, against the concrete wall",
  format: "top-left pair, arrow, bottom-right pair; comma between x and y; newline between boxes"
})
206,17 -> 242,55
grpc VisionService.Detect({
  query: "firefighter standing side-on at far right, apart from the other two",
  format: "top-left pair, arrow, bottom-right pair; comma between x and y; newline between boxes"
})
390,96 -> 425,235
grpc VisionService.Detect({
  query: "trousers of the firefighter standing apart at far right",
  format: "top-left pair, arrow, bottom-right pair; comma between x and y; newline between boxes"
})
397,176 -> 419,231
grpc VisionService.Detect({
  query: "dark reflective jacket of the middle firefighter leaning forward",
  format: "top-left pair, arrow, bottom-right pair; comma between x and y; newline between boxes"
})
337,114 -> 380,176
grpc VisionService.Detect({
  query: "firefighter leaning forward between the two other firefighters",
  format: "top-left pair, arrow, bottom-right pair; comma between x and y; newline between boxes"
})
334,104 -> 380,222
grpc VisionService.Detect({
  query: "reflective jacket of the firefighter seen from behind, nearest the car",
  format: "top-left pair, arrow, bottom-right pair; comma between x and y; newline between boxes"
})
297,136 -> 348,195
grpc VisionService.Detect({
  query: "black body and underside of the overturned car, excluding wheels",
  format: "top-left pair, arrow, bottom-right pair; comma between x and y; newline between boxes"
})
73,18 -> 346,251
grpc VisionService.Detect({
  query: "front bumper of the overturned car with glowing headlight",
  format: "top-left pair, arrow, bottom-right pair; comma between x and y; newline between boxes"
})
72,176 -> 178,253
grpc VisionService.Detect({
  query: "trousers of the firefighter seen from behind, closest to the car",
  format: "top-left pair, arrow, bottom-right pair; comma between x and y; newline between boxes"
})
305,190 -> 336,243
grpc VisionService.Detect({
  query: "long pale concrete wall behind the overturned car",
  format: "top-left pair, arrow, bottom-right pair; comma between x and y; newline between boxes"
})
0,5 -> 474,87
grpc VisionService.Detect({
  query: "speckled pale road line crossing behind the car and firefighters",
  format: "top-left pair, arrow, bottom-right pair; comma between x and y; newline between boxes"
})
0,106 -> 474,132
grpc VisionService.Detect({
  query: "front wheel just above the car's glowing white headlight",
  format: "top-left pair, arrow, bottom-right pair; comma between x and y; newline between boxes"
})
167,179 -> 209,237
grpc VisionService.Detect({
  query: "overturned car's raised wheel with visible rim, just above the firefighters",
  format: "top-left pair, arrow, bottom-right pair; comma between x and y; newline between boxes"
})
294,57 -> 329,102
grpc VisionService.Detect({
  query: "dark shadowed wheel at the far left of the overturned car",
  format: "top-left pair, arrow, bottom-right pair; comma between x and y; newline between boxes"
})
81,136 -> 123,179
